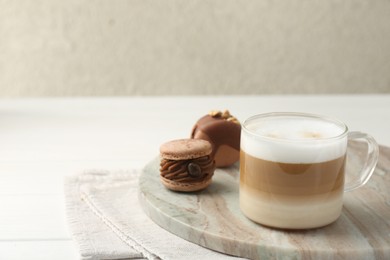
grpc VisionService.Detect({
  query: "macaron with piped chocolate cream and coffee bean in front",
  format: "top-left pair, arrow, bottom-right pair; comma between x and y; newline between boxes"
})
160,139 -> 215,192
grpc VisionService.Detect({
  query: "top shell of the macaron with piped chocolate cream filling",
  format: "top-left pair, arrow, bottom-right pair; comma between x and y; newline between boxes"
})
160,139 -> 212,160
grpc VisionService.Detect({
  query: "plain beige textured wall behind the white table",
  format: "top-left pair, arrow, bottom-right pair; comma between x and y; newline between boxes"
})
0,0 -> 390,97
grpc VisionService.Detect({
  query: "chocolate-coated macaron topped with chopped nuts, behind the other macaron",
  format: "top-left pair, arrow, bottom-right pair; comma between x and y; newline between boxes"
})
191,110 -> 241,167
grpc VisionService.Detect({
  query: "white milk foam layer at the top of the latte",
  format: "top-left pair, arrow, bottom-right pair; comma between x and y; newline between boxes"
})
241,117 -> 347,163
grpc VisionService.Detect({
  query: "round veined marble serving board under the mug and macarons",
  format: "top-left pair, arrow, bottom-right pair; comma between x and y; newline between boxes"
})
139,145 -> 390,259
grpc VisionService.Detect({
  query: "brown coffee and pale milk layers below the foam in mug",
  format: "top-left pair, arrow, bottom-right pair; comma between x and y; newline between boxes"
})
240,151 -> 345,229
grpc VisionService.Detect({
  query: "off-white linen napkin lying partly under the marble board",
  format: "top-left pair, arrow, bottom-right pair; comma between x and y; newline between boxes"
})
64,170 -> 245,260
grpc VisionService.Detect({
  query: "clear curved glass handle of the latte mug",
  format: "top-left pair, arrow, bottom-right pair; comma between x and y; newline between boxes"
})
344,132 -> 379,192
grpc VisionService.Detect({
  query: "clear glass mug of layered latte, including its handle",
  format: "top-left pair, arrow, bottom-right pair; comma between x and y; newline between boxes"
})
240,112 -> 379,229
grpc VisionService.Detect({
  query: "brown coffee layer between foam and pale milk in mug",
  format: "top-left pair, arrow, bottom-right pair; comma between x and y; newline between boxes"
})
240,150 -> 345,196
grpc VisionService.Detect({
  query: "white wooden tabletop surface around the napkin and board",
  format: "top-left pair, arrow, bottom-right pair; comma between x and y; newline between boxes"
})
0,95 -> 390,259
